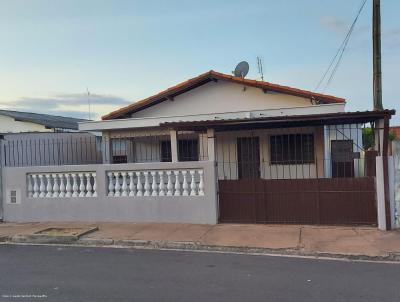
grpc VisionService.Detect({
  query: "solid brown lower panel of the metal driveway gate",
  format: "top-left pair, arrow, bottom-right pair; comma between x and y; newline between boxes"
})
218,177 -> 377,225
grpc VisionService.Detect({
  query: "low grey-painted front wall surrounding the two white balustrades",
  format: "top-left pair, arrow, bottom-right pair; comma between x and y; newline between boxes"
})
3,161 -> 217,224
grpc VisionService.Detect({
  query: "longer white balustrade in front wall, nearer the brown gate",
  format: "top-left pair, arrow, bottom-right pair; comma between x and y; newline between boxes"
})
107,169 -> 204,197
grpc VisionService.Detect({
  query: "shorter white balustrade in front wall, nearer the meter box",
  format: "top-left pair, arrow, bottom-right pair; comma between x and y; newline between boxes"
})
27,172 -> 97,198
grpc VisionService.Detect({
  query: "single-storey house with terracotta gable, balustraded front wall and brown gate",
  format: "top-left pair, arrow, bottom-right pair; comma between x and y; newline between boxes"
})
4,71 -> 394,228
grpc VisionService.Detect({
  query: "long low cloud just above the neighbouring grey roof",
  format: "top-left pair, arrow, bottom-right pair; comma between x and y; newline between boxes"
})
0,93 -> 130,119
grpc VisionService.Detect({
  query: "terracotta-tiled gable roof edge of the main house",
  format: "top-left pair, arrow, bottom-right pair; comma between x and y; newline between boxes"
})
102,70 -> 345,120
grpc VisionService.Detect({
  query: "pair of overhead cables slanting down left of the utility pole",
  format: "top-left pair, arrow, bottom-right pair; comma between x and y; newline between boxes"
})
314,0 -> 367,91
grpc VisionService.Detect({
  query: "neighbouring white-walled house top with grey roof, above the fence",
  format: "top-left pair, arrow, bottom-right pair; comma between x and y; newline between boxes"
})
0,110 -> 85,133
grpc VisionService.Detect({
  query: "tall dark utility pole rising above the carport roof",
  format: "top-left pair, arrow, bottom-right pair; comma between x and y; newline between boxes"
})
372,0 -> 383,110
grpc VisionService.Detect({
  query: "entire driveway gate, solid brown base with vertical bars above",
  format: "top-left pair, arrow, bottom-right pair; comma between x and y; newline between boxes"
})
216,125 -> 377,225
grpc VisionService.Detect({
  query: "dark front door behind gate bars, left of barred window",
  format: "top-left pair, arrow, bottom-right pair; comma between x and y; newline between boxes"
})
237,137 -> 260,179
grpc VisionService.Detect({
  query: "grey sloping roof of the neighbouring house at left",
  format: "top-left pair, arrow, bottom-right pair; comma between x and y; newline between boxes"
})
0,110 -> 86,130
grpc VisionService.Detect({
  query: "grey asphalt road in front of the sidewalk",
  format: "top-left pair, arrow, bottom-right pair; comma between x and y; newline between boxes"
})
0,245 -> 400,302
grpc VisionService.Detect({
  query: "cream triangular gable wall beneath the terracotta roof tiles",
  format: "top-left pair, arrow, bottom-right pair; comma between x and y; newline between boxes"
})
131,81 -> 344,118
